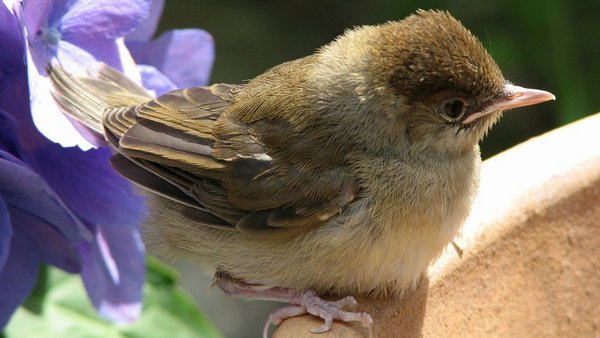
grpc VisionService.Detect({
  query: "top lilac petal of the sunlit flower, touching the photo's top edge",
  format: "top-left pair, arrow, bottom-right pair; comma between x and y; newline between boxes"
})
60,0 -> 150,41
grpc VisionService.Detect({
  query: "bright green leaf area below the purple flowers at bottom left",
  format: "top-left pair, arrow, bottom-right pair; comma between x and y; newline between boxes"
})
4,258 -> 222,338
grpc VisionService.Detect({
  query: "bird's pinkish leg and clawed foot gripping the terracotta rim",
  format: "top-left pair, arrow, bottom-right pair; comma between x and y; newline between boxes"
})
213,272 -> 373,337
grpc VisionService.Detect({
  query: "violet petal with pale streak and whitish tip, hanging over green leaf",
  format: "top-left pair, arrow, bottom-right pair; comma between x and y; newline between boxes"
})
81,226 -> 145,322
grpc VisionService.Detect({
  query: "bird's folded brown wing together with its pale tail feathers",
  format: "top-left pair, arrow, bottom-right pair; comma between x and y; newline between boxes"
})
51,60 -> 358,239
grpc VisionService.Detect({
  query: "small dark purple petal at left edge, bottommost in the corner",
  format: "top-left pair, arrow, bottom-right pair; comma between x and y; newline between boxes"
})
0,224 -> 40,327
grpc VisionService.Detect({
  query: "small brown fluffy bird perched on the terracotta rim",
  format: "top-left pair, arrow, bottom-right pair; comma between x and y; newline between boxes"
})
50,10 -> 555,336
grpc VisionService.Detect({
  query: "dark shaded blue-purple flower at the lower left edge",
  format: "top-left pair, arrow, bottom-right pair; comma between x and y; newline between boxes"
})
0,109 -> 91,327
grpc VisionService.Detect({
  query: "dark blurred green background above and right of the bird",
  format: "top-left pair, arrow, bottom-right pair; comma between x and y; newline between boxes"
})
160,0 -> 600,157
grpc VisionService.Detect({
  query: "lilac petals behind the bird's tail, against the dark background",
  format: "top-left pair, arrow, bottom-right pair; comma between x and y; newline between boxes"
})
125,0 -> 215,95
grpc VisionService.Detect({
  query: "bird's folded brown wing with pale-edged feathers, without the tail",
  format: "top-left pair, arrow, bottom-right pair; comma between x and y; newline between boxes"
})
103,73 -> 358,235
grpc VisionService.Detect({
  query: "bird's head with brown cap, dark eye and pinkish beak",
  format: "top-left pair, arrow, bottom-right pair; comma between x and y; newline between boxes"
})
317,11 -> 554,154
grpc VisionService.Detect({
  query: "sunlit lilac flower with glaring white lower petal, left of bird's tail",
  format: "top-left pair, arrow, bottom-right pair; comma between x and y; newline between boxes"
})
21,0 -> 150,150
